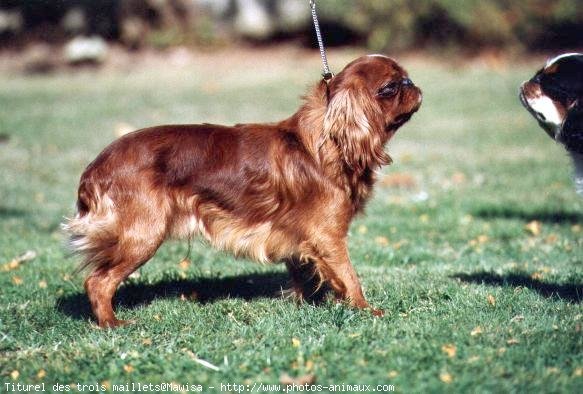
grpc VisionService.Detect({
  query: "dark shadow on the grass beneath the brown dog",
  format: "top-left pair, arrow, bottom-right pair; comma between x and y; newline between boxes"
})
56,272 -> 288,319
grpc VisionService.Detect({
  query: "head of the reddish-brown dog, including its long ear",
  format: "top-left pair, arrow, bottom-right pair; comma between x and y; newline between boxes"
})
324,55 -> 422,170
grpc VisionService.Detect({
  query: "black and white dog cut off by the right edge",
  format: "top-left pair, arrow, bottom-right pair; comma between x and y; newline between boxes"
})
520,53 -> 583,195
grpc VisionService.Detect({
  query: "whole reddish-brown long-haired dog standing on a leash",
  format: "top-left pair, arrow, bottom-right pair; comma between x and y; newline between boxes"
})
64,55 -> 421,327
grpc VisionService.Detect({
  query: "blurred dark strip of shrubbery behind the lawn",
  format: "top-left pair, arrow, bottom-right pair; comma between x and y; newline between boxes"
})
0,0 -> 583,73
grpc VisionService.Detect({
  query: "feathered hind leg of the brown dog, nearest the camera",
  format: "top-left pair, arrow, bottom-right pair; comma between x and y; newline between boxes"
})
67,194 -> 166,328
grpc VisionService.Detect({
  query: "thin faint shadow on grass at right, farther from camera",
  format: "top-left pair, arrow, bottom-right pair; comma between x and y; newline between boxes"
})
471,206 -> 583,223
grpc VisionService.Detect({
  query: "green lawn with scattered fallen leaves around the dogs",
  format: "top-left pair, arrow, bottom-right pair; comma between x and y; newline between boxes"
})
0,53 -> 583,392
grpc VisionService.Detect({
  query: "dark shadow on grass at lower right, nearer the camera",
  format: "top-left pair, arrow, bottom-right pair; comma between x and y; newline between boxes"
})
452,272 -> 583,303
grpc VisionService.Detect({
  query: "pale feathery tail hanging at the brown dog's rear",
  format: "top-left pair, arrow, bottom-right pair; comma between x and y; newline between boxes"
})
61,181 -> 118,273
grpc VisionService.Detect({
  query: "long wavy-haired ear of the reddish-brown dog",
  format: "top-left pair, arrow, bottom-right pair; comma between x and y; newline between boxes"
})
324,83 -> 391,172
